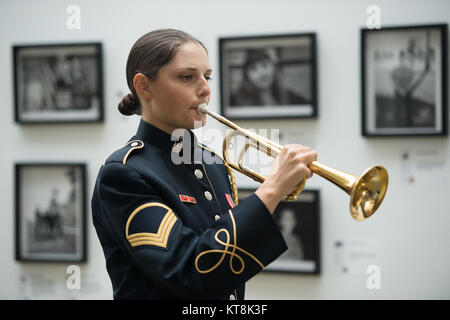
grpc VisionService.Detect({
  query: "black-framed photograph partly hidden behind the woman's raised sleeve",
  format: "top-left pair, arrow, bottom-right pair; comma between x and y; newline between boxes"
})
239,189 -> 320,274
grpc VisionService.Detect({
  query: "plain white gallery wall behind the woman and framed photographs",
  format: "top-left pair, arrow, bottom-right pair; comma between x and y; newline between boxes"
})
0,0 -> 450,299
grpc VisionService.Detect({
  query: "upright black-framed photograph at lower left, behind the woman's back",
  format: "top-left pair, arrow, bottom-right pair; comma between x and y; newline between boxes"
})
15,163 -> 86,262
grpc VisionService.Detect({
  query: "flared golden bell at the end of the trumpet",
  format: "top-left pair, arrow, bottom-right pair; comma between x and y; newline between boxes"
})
350,166 -> 389,221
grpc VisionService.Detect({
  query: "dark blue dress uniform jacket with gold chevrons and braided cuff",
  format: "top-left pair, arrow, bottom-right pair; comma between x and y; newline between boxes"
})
92,120 -> 287,299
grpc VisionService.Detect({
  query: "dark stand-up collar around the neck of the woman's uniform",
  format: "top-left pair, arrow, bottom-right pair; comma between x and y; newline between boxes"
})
136,119 -> 197,151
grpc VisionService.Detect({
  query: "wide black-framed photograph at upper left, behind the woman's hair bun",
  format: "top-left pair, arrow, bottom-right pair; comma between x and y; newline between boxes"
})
13,43 -> 103,123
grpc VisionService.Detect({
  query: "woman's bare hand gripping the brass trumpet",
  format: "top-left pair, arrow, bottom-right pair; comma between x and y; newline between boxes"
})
255,144 -> 317,213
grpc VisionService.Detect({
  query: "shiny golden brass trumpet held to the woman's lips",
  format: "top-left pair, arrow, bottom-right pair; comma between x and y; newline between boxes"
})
197,103 -> 389,221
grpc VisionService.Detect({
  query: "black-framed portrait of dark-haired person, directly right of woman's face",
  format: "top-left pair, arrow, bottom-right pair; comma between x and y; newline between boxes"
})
219,33 -> 317,119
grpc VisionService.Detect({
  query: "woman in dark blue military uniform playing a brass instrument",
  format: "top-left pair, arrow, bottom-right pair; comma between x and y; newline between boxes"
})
92,29 -> 317,299
